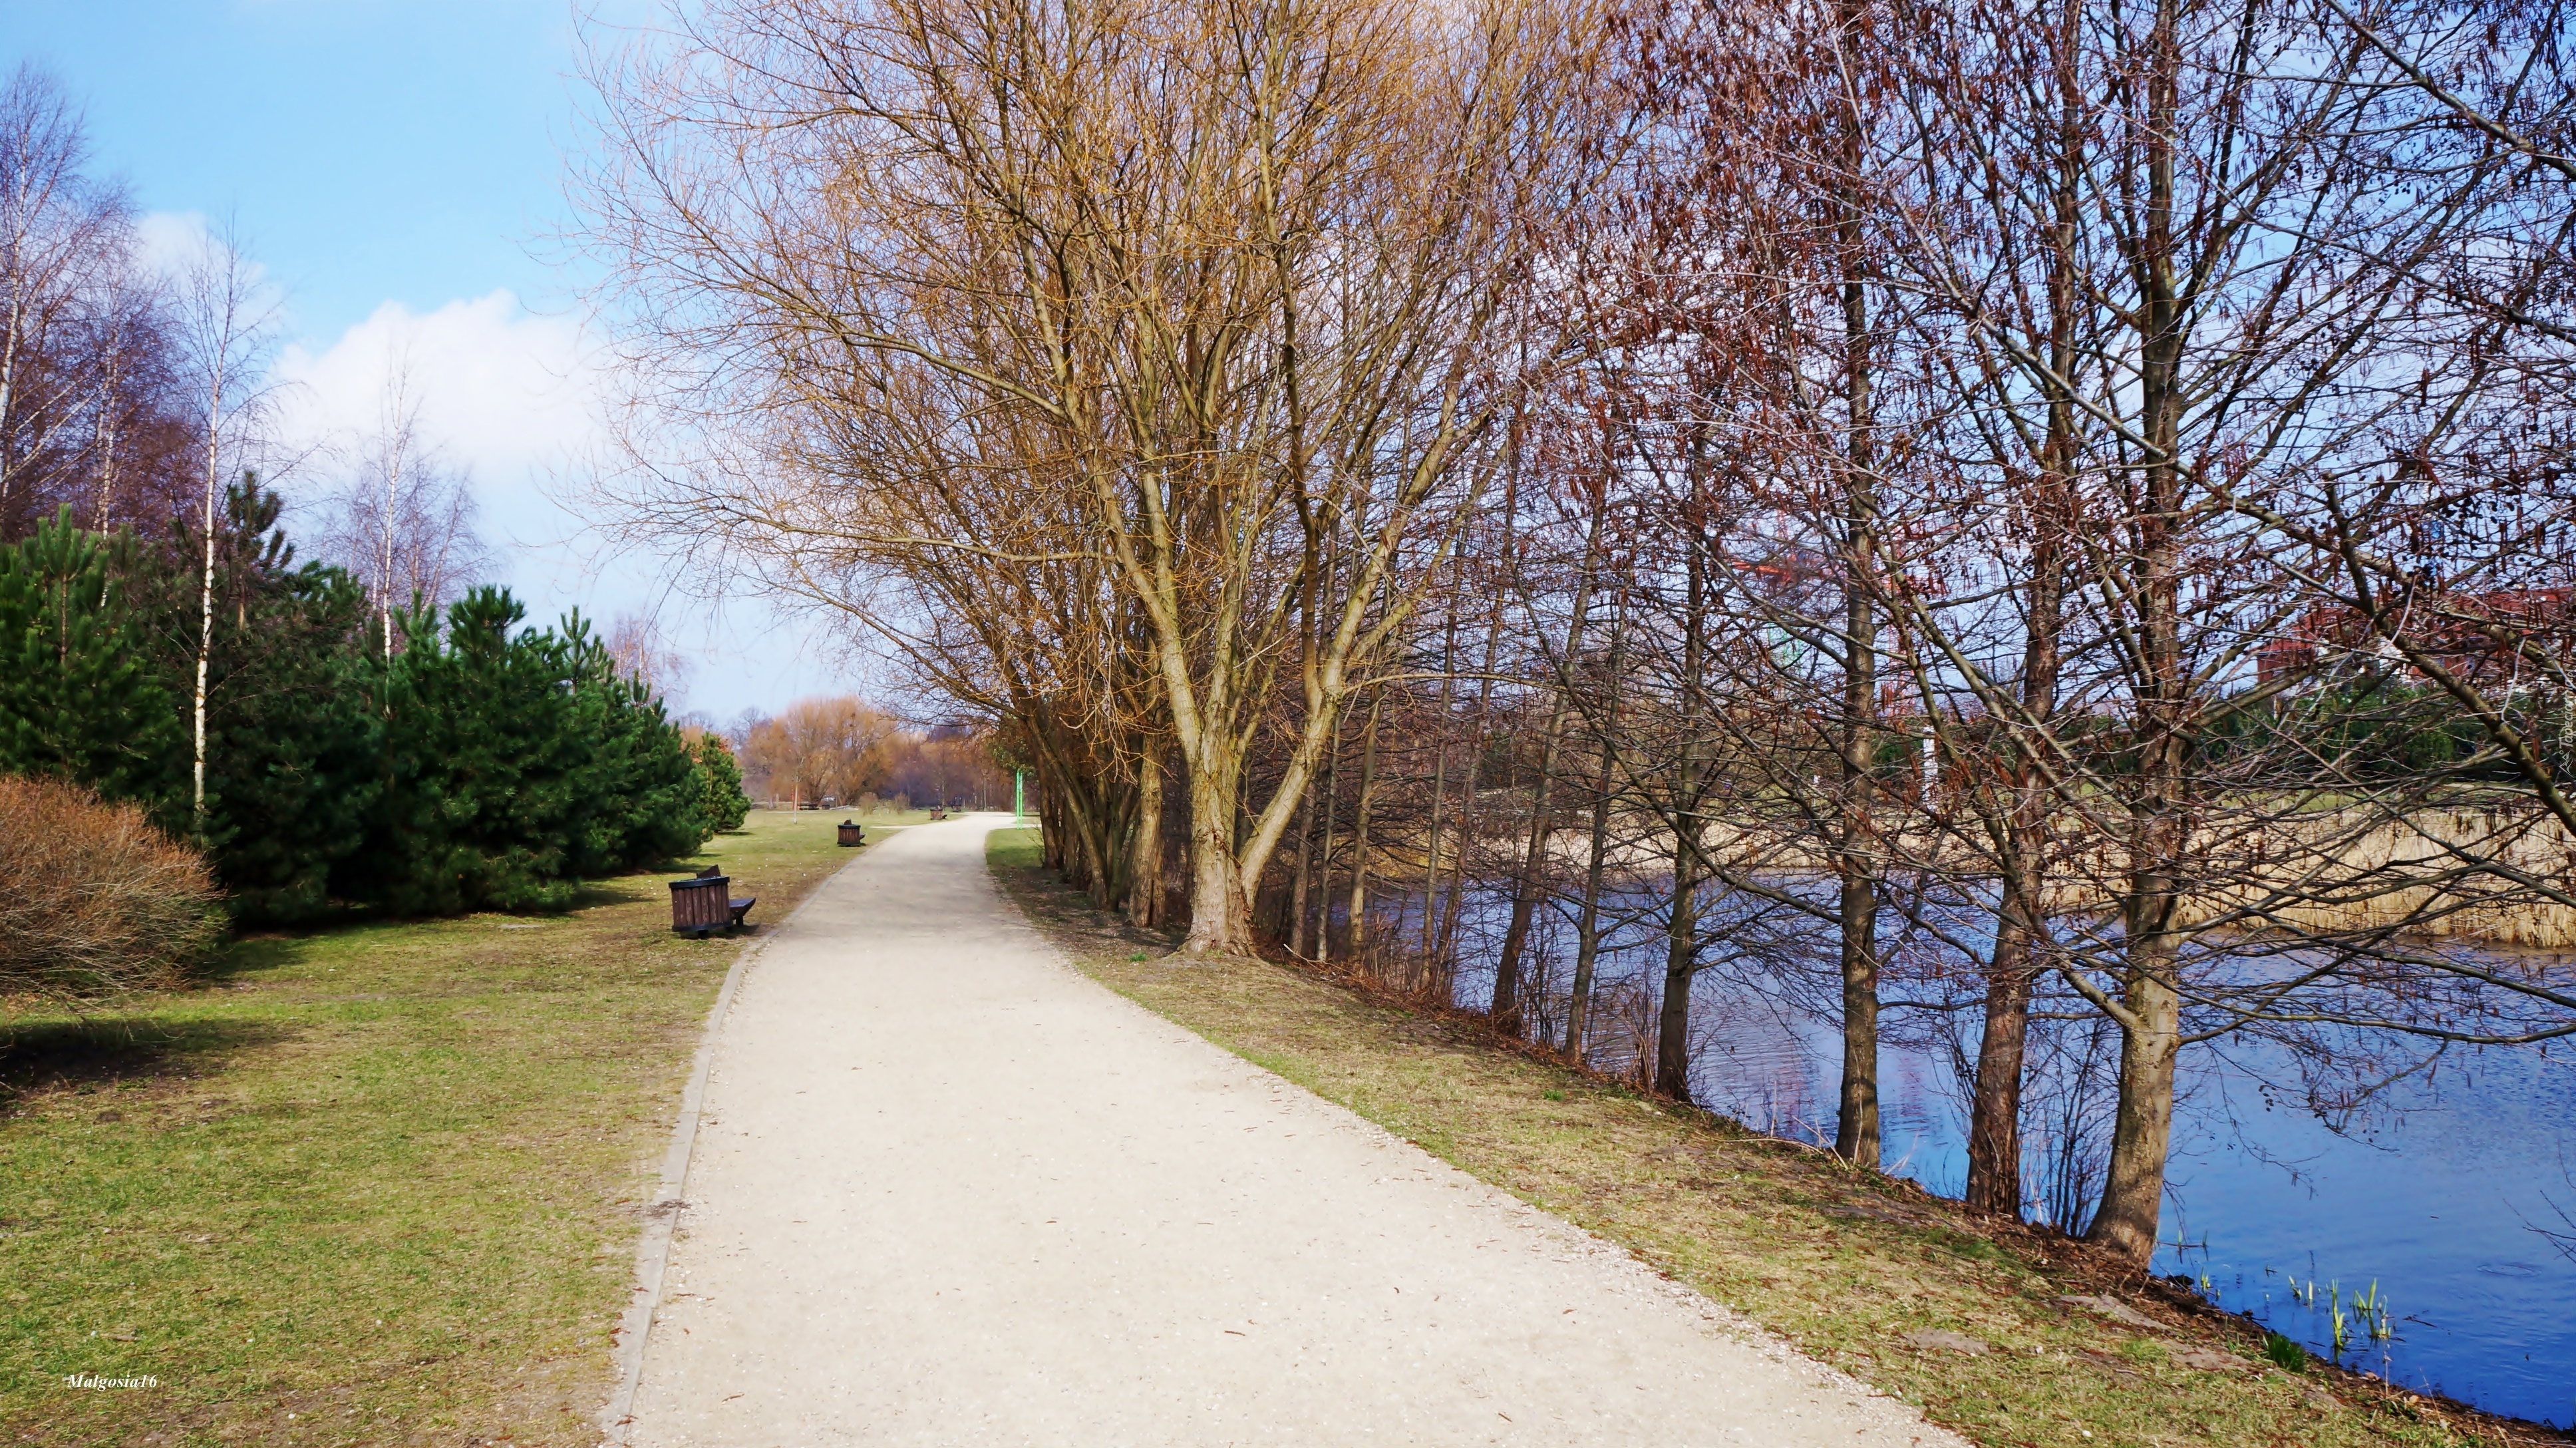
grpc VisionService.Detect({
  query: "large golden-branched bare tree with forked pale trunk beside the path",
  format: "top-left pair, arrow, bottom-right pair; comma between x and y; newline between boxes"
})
577,0 -> 1595,951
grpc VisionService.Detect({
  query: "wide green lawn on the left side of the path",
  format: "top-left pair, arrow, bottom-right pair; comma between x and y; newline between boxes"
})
0,812 -> 899,1448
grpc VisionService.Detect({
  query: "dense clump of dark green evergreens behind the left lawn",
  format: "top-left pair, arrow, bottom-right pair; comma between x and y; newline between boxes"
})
15,492 -> 721,922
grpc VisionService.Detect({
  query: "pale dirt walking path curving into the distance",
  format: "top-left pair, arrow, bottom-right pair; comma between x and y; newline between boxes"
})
607,816 -> 1963,1448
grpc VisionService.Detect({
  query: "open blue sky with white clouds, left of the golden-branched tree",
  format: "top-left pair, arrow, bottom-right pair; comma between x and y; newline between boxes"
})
0,0 -> 840,719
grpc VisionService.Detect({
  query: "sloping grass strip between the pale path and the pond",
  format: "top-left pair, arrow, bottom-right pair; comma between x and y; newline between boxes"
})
989,830 -> 2571,1448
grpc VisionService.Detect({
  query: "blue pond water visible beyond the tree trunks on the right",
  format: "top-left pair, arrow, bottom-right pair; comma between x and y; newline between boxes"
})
1388,894 -> 2576,1427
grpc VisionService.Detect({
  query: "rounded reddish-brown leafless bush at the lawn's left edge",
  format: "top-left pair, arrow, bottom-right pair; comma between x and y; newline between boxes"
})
0,775 -> 222,999
